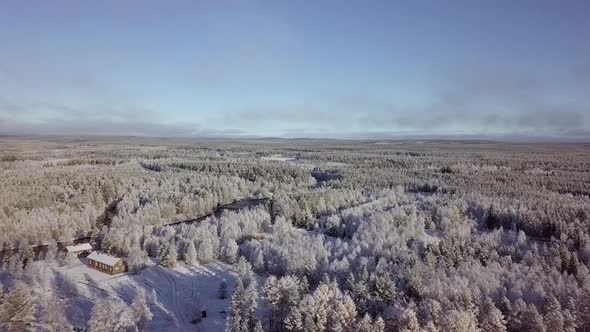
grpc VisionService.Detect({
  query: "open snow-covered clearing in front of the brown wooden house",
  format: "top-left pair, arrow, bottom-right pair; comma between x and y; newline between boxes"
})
58,259 -> 236,332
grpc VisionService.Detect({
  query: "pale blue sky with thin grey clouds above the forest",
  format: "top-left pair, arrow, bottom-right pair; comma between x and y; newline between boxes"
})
0,0 -> 590,140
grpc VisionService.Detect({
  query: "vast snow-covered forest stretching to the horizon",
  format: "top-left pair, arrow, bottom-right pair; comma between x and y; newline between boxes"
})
0,138 -> 590,332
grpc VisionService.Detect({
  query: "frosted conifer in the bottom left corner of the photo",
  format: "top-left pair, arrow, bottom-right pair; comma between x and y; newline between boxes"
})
0,282 -> 37,332
